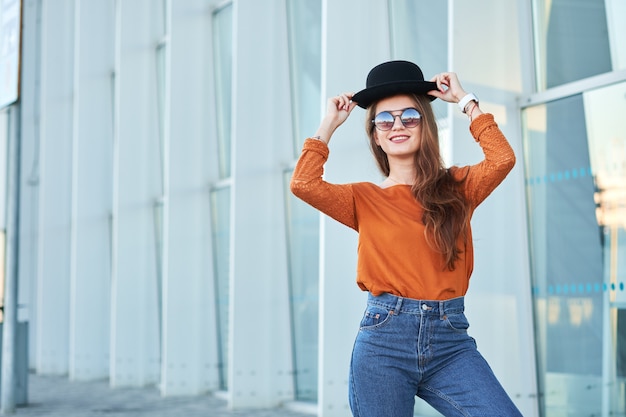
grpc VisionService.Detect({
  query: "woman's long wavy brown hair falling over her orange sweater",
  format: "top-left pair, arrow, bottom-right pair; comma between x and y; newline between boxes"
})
365,94 -> 469,271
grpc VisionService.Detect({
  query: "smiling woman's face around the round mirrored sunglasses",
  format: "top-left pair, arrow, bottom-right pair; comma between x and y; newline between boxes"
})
374,95 -> 422,158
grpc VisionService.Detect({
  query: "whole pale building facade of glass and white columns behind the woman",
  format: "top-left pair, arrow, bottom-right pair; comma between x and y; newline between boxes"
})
0,0 -> 626,417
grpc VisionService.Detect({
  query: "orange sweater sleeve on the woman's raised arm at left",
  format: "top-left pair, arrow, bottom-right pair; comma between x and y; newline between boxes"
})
290,139 -> 358,230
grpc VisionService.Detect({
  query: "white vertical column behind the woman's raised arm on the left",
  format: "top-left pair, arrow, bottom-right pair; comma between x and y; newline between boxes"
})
311,0 -> 391,417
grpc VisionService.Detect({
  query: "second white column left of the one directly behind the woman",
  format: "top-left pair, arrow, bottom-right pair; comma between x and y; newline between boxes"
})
161,0 -> 219,395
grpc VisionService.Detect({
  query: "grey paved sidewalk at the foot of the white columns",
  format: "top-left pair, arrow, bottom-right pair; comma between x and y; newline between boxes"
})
14,374 -> 312,417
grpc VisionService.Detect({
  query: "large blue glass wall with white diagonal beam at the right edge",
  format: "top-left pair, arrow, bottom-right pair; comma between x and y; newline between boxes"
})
522,1 -> 626,416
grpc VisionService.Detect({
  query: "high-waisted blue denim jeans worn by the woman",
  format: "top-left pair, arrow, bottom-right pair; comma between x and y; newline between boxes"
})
349,294 -> 521,417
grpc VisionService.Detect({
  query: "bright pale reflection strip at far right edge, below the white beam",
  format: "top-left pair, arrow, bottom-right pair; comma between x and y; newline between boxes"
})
584,83 -> 626,415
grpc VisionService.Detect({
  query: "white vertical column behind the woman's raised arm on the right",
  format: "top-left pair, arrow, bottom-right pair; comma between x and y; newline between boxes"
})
450,0 -> 538,416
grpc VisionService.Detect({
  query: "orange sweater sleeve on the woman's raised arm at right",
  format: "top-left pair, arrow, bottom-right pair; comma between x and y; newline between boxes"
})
459,113 -> 515,208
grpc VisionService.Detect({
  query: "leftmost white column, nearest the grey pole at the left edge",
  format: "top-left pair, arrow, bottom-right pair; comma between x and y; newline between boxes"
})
34,0 -> 74,374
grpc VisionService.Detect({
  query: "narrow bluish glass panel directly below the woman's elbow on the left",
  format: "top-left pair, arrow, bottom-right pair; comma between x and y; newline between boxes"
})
285,172 -> 319,402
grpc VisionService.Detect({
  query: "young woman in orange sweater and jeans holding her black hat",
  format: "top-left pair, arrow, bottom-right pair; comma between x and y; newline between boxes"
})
291,61 -> 521,417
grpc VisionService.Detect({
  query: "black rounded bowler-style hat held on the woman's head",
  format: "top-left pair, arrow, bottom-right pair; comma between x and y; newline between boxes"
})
352,61 -> 437,109
